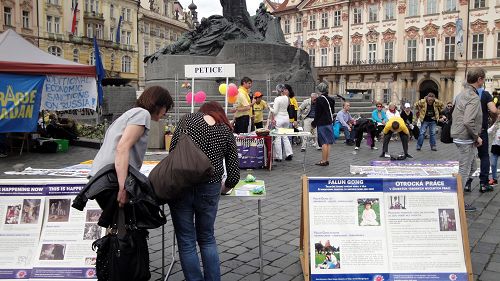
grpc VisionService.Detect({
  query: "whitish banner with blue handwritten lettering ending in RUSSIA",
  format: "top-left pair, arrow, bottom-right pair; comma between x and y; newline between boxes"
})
41,75 -> 97,111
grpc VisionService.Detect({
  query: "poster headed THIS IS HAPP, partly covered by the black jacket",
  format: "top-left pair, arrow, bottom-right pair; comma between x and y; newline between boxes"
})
31,184 -> 105,280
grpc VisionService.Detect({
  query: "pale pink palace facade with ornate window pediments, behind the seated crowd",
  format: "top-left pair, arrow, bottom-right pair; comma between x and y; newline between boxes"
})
266,0 -> 500,104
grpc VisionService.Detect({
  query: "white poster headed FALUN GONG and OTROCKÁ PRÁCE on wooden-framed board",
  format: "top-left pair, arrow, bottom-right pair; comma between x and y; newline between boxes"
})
309,177 -> 467,281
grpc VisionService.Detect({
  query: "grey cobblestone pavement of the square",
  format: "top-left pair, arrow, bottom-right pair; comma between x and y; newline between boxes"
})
0,140 -> 500,281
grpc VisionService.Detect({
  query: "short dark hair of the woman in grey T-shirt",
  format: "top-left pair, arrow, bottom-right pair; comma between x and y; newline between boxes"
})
135,86 -> 174,114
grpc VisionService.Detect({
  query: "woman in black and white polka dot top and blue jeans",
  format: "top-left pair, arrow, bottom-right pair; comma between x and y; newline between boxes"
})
169,101 -> 240,280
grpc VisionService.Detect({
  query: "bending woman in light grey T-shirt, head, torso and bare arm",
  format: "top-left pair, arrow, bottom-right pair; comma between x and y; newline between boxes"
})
89,86 -> 173,207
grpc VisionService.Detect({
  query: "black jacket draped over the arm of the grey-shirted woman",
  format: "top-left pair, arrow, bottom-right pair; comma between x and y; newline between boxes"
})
72,164 -> 167,229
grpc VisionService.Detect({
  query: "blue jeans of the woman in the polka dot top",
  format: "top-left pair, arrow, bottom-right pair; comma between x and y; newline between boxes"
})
169,183 -> 221,281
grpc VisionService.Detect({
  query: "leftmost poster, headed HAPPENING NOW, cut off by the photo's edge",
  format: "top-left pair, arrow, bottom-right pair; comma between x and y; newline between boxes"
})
0,188 -> 45,279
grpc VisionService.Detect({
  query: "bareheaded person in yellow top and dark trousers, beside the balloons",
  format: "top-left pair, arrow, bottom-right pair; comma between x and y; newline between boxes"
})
234,77 -> 254,134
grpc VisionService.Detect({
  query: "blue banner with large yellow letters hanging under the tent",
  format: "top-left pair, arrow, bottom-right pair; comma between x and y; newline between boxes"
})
0,73 -> 45,133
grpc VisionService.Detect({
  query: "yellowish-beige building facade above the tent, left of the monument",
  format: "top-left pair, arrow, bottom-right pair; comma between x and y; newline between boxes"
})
0,0 -> 191,88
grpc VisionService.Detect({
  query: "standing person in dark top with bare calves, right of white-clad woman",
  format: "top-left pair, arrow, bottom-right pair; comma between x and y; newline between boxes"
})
311,82 -> 335,166
